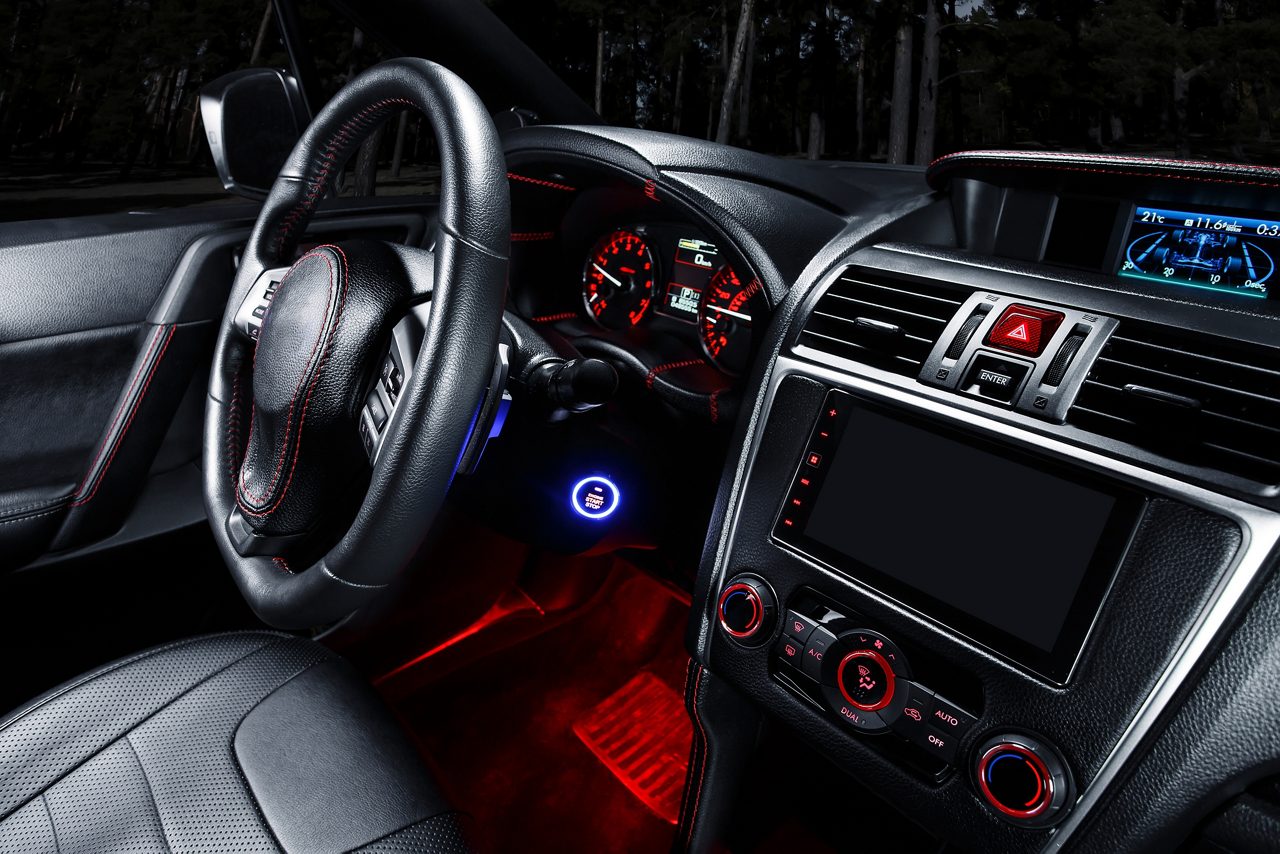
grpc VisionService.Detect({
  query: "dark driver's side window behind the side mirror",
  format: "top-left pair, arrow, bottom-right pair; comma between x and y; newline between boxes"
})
0,0 -> 288,220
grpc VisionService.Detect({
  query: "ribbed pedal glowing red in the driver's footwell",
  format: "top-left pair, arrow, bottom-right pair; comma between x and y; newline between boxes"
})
573,672 -> 694,825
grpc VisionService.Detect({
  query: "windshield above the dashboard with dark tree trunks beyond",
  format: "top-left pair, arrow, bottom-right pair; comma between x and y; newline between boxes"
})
489,0 -> 1280,164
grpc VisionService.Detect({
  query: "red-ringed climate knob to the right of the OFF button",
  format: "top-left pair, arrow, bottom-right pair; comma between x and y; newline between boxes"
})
974,735 -> 1071,827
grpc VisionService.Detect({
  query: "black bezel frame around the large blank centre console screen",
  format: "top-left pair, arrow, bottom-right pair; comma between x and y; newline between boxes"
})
773,389 -> 1147,685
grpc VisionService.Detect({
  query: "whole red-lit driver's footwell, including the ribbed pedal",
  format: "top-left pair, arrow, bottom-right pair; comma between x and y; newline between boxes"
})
380,565 -> 691,853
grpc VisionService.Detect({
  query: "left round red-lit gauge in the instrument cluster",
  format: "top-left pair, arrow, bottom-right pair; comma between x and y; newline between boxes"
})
582,230 -> 655,329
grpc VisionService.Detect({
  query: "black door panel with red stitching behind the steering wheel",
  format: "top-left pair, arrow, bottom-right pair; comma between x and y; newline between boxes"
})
0,200 -> 430,570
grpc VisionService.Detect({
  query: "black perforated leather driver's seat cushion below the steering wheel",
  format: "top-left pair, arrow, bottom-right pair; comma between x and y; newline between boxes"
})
0,631 -> 468,854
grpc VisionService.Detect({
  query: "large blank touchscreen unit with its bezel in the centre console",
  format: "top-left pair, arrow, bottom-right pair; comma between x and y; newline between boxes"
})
777,392 -> 1140,680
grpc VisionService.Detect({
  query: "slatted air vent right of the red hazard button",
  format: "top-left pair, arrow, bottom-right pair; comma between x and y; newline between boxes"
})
1068,320 -> 1280,484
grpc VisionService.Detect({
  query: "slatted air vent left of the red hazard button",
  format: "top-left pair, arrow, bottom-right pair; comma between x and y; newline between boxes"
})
800,268 -> 969,376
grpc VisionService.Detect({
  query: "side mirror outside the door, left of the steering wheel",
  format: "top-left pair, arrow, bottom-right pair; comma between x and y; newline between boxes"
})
200,68 -> 311,198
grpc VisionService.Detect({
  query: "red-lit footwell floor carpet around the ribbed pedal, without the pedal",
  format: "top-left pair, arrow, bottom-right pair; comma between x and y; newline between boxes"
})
383,571 -> 689,854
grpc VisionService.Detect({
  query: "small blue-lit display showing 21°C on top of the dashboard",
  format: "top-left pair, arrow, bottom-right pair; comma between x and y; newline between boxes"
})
1117,205 -> 1280,298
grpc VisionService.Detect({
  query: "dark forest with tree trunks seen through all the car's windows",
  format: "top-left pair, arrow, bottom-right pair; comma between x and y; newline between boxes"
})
0,0 -> 1280,219
